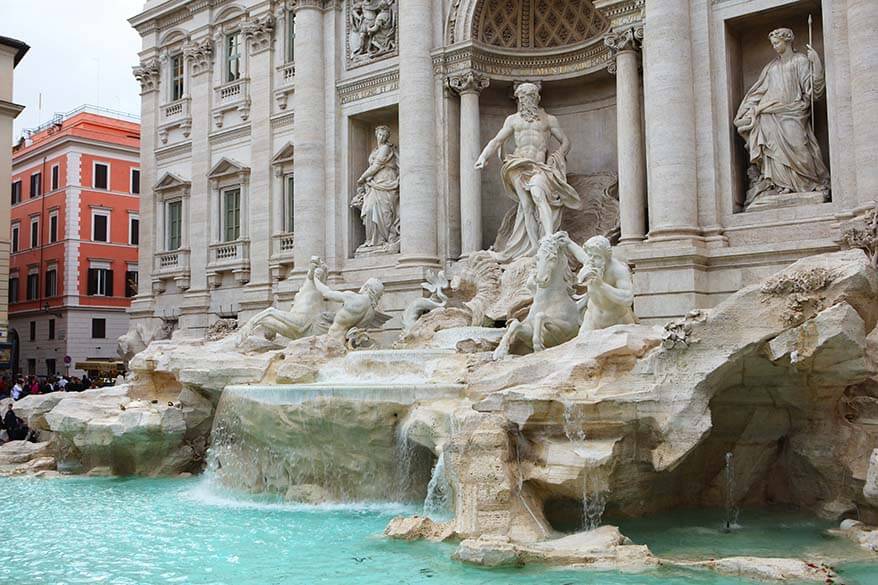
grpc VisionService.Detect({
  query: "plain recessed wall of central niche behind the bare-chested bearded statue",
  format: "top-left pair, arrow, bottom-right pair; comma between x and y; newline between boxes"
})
472,70 -> 618,248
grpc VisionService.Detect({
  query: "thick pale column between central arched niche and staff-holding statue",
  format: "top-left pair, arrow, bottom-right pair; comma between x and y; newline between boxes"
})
643,0 -> 699,240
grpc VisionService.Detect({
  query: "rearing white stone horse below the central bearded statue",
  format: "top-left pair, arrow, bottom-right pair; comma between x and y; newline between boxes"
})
494,232 -> 581,360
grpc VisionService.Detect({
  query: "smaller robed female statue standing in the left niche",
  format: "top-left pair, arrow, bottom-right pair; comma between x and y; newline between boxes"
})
351,126 -> 399,256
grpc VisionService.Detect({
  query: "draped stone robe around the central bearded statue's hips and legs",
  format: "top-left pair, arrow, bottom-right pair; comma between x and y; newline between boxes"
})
494,152 -> 582,263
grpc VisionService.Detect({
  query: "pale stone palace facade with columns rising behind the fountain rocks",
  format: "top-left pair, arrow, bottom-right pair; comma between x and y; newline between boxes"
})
131,0 -> 878,335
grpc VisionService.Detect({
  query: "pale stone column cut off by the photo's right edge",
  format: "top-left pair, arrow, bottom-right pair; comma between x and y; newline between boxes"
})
847,0 -> 878,205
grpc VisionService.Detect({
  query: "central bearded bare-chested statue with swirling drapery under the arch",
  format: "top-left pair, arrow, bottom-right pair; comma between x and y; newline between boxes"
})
476,83 -> 582,263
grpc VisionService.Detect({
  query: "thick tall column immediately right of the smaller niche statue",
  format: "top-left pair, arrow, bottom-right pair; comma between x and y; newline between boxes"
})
398,0 -> 439,265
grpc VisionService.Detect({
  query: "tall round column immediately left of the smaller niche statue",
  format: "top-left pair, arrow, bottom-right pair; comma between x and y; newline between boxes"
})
293,0 -> 326,272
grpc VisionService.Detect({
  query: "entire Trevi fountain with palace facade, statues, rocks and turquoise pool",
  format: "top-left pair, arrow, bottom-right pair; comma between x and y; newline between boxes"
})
0,0 -> 878,585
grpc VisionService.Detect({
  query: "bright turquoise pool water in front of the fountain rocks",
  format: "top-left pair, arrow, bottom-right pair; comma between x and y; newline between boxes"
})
0,478 -> 878,585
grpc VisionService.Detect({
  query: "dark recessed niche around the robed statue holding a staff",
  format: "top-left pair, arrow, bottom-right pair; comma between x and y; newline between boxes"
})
725,0 -> 832,213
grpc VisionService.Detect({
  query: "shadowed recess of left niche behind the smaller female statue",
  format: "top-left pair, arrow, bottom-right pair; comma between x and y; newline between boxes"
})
346,104 -> 399,258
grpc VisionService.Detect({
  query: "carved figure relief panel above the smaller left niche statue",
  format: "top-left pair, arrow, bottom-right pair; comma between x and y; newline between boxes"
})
346,0 -> 399,69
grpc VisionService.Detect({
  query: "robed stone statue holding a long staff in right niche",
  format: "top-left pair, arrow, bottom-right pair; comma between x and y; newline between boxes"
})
734,28 -> 829,206
